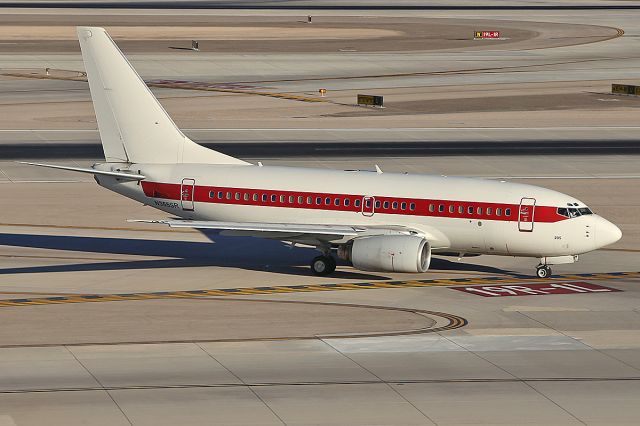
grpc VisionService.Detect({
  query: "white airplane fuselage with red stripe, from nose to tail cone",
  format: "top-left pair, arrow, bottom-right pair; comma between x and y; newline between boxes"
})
94,163 -> 621,263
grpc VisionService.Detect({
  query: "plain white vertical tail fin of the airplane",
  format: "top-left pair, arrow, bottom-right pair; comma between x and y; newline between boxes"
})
77,27 -> 248,164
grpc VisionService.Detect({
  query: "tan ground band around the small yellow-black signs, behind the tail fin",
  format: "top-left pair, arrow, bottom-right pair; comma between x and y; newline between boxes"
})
0,82 -> 640,129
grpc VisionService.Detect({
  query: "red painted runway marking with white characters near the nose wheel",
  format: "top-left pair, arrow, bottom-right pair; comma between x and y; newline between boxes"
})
451,282 -> 622,297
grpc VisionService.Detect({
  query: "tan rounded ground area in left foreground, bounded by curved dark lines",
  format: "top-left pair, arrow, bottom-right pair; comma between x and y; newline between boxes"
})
0,299 -> 435,346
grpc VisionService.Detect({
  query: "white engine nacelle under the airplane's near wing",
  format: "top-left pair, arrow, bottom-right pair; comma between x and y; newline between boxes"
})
338,235 -> 431,272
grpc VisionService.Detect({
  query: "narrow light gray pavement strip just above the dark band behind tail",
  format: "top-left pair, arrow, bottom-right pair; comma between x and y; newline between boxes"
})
0,125 -> 640,146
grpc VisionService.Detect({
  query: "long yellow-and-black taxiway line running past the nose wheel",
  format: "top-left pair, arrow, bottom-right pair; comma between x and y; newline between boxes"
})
0,271 -> 640,307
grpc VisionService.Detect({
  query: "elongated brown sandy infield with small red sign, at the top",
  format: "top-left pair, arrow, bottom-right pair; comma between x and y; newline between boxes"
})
0,15 -> 620,53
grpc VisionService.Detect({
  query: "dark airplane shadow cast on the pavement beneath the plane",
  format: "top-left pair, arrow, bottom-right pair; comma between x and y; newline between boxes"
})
0,232 -> 510,280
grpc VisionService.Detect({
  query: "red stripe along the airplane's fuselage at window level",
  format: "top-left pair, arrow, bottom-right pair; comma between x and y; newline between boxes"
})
142,181 -> 567,222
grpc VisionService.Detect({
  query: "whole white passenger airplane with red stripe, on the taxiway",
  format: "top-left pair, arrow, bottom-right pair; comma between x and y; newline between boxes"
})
22,27 -> 622,278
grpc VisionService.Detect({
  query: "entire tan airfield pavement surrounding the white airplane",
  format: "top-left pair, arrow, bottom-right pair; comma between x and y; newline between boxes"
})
0,1 -> 640,426
